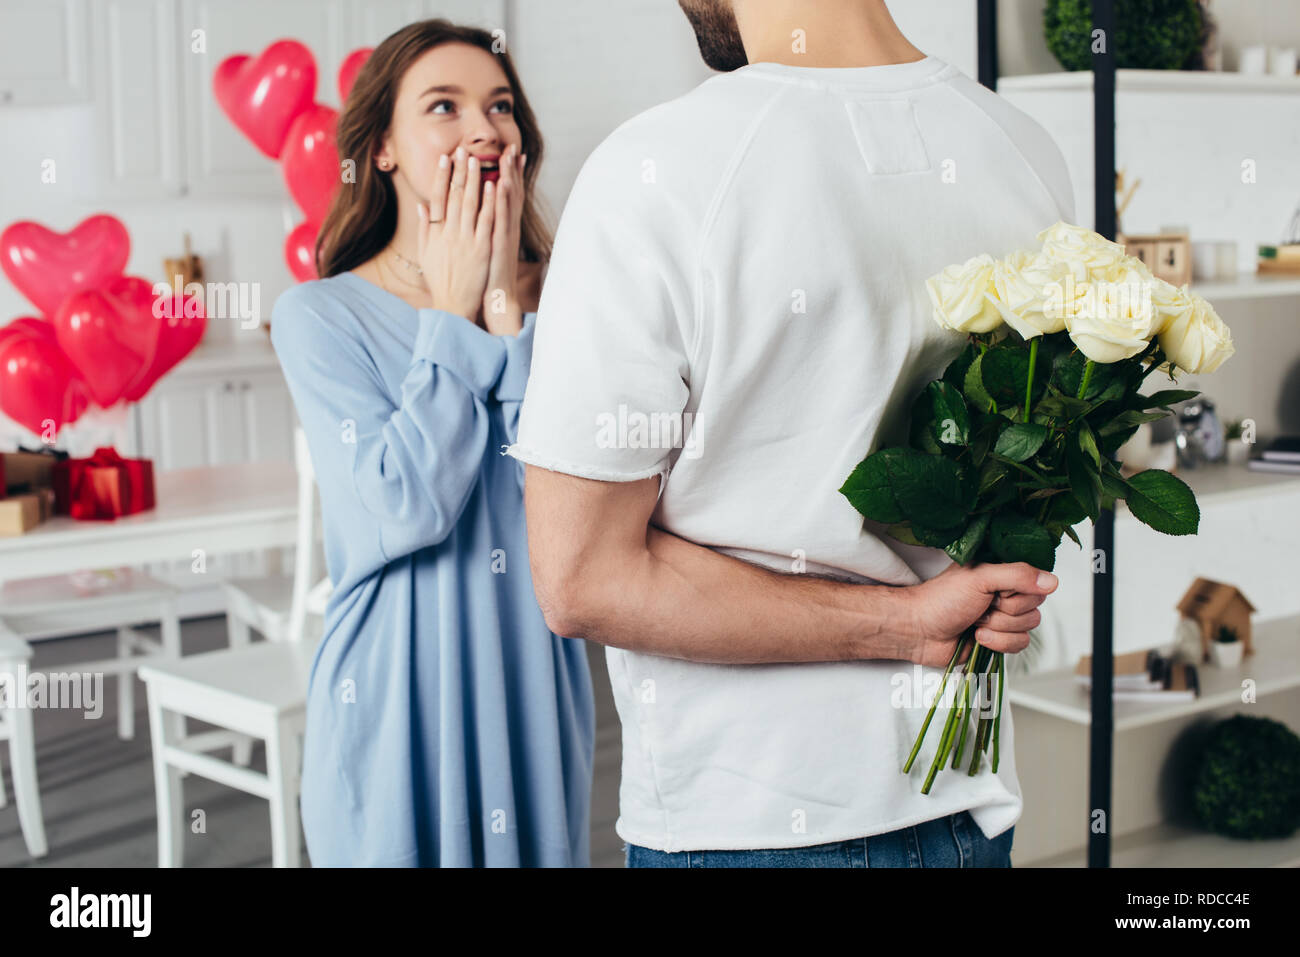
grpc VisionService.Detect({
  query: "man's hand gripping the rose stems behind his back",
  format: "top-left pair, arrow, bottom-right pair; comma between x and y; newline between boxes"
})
904,562 -> 1057,668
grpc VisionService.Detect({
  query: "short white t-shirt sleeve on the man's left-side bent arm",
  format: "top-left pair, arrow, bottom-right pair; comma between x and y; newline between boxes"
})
506,140 -> 693,492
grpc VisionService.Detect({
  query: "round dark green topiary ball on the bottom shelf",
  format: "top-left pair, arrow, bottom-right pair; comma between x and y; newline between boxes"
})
1192,714 -> 1300,839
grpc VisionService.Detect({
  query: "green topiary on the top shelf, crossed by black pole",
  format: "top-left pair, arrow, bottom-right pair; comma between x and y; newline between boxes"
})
1043,0 -> 1203,70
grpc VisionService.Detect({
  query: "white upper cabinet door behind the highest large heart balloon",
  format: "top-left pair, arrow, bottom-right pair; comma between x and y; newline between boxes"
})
177,0 -> 359,199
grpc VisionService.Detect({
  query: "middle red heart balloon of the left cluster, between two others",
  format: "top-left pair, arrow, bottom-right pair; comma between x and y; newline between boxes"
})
55,276 -> 163,408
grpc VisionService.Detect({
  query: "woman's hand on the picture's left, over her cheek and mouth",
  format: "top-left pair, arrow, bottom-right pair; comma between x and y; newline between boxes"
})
417,147 -> 497,322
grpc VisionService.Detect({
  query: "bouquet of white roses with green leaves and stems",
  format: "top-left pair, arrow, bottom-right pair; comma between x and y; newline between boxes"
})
840,222 -> 1234,794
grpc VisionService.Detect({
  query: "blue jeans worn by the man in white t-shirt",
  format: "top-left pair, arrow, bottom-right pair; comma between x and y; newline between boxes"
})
627,811 -> 1015,867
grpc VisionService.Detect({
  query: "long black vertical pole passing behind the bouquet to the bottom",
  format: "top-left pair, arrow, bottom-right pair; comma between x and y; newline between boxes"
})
1087,0 -> 1117,867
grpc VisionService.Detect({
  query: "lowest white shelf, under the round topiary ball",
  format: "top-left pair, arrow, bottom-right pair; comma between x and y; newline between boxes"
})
1013,824 -> 1300,867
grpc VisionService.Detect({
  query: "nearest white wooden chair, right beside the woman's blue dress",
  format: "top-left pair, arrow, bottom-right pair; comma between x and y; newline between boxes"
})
140,429 -> 322,867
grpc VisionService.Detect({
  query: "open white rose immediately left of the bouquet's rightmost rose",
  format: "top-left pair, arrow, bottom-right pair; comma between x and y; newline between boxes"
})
1065,261 -> 1165,364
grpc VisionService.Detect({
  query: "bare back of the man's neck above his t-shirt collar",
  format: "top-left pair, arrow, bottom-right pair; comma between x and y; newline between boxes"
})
735,0 -> 926,68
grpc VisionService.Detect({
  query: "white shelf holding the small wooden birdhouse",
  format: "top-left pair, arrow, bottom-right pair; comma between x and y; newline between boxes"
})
1008,616 -> 1300,733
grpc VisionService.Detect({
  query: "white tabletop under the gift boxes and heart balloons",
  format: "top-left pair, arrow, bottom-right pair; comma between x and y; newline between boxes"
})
0,462 -> 298,581
